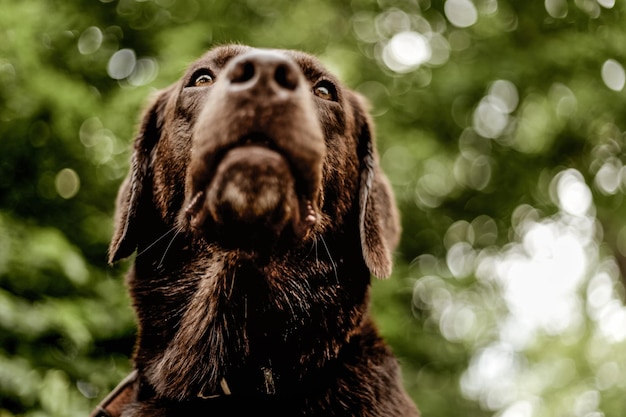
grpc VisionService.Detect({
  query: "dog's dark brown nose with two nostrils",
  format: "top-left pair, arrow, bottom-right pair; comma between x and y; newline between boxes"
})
226,50 -> 301,94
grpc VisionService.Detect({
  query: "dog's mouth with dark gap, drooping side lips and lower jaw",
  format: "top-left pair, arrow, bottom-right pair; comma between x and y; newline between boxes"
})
185,134 -> 320,245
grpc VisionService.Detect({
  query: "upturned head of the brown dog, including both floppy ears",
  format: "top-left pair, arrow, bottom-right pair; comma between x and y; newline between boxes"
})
110,46 -> 399,277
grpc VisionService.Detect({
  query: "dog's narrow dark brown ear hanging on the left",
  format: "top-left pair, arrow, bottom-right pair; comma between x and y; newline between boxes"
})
109,90 -> 169,263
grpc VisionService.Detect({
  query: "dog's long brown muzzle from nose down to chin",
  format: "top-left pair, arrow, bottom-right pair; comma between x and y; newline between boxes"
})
185,50 -> 325,242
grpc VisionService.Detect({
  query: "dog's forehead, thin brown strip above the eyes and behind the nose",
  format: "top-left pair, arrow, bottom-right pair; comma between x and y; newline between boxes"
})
190,45 -> 338,82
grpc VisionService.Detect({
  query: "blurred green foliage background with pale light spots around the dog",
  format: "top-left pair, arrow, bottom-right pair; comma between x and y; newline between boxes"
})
0,0 -> 626,417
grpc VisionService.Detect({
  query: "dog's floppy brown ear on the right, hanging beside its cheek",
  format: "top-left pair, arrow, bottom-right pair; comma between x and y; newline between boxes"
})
351,94 -> 400,278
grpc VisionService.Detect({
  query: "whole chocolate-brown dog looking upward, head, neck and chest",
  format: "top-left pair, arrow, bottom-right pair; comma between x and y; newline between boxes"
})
98,46 -> 418,417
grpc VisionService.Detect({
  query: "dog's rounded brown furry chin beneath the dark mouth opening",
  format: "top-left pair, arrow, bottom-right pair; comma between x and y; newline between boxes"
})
187,145 -> 317,248
